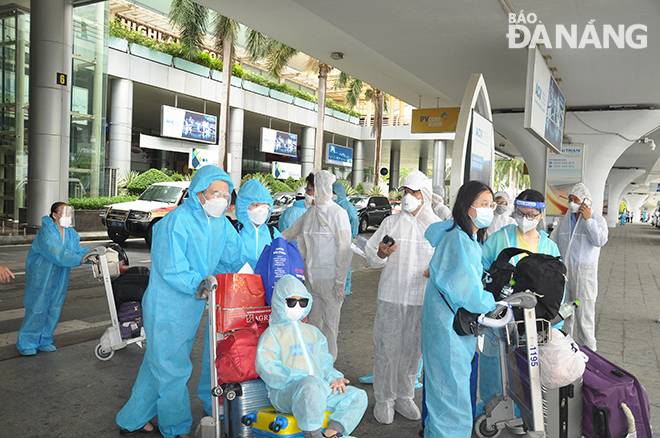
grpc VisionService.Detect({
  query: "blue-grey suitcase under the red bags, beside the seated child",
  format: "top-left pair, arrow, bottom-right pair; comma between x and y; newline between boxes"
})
222,379 -> 272,438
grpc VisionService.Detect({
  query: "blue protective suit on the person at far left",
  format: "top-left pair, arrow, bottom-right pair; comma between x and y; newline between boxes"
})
16,216 -> 89,351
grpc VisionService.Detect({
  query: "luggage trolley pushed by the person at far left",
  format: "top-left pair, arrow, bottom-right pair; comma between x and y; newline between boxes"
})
93,244 -> 146,361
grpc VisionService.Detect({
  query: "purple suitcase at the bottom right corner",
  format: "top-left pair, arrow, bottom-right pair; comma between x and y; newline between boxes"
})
580,346 -> 653,438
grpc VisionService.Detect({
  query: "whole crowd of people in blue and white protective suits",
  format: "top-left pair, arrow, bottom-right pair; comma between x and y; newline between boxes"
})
10,165 -> 608,438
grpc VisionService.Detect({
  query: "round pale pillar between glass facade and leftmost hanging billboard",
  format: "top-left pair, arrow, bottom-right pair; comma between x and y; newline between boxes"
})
108,79 -> 133,176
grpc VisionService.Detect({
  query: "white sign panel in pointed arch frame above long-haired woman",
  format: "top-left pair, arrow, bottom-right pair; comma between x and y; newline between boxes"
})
465,110 -> 495,186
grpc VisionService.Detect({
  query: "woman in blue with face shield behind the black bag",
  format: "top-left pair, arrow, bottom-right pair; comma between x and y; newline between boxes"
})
476,189 -> 563,415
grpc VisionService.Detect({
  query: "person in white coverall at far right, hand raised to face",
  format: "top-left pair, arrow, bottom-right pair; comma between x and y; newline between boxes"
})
550,183 -> 608,351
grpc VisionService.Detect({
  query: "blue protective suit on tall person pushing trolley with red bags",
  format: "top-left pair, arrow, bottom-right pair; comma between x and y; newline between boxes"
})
116,165 -> 242,438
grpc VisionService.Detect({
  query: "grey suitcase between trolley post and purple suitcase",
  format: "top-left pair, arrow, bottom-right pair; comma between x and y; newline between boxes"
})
542,377 -> 582,438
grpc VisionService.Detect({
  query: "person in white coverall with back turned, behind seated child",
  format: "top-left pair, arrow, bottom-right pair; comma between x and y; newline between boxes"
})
282,170 -> 353,360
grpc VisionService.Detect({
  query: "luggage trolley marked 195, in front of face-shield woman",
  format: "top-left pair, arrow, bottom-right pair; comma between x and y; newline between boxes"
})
473,291 -> 550,438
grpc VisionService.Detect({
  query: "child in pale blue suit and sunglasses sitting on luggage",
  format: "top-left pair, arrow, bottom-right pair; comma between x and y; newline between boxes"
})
256,275 -> 368,438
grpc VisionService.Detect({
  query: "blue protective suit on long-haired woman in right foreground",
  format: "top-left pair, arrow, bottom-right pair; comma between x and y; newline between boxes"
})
422,220 -> 495,438
